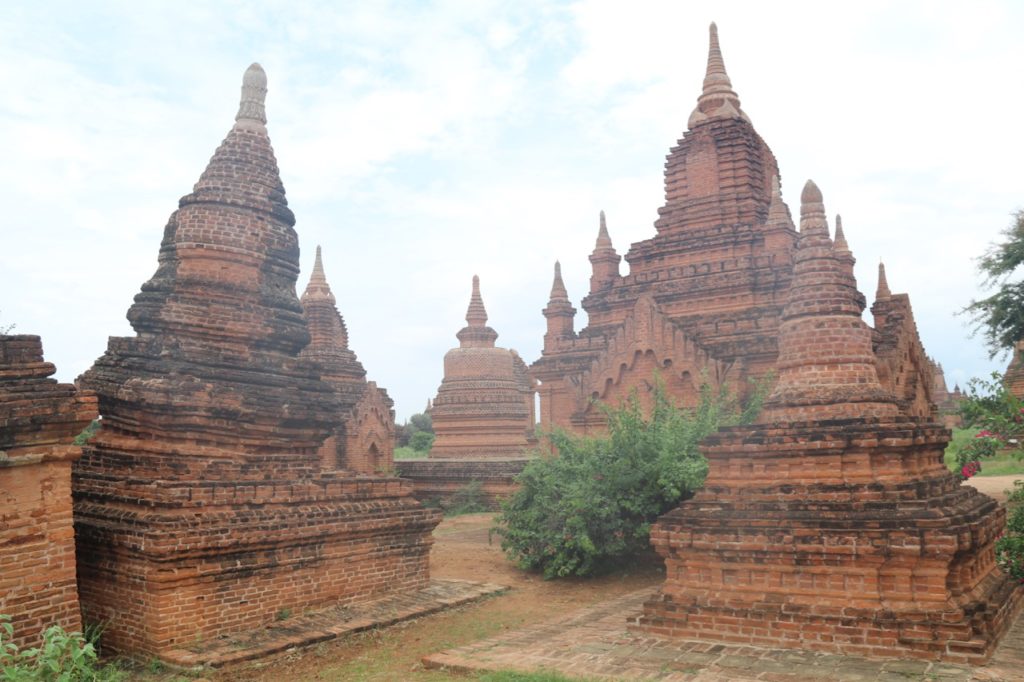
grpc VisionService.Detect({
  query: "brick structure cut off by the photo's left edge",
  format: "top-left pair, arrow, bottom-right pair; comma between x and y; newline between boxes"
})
0,335 -> 96,648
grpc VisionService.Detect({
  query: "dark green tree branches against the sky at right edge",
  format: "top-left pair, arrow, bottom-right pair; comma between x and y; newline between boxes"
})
961,210 -> 1024,357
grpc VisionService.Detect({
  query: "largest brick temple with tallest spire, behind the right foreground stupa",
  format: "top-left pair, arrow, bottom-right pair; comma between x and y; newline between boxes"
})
530,25 -> 935,433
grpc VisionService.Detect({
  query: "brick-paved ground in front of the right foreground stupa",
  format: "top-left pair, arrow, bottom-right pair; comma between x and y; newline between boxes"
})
423,590 -> 1024,682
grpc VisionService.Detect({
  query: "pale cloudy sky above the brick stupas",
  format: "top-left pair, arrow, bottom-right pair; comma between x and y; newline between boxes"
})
0,0 -> 1024,421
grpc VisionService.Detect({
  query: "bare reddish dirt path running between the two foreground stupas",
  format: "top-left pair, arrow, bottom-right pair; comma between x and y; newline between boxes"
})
202,514 -> 664,682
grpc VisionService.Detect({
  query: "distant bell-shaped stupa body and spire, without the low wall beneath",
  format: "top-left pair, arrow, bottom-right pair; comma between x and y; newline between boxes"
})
430,274 -> 535,459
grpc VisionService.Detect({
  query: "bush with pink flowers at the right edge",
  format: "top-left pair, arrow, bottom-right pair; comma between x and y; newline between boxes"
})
953,372 -> 1024,479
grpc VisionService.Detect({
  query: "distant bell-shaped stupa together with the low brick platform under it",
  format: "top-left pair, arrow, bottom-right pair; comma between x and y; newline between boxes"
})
398,275 -> 537,507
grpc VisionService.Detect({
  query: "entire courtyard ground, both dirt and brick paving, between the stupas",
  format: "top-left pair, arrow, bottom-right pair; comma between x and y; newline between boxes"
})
121,485 -> 1024,682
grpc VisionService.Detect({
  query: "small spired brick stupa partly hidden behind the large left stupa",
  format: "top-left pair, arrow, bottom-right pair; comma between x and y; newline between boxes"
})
301,247 -> 394,474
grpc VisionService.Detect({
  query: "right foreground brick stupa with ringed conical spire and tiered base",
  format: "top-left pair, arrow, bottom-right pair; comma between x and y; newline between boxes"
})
638,182 -> 1024,663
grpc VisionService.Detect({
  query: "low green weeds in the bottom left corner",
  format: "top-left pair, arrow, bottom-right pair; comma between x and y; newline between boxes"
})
0,615 -> 124,682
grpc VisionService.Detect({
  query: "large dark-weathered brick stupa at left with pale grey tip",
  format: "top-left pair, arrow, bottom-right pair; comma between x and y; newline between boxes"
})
74,65 -> 440,660
